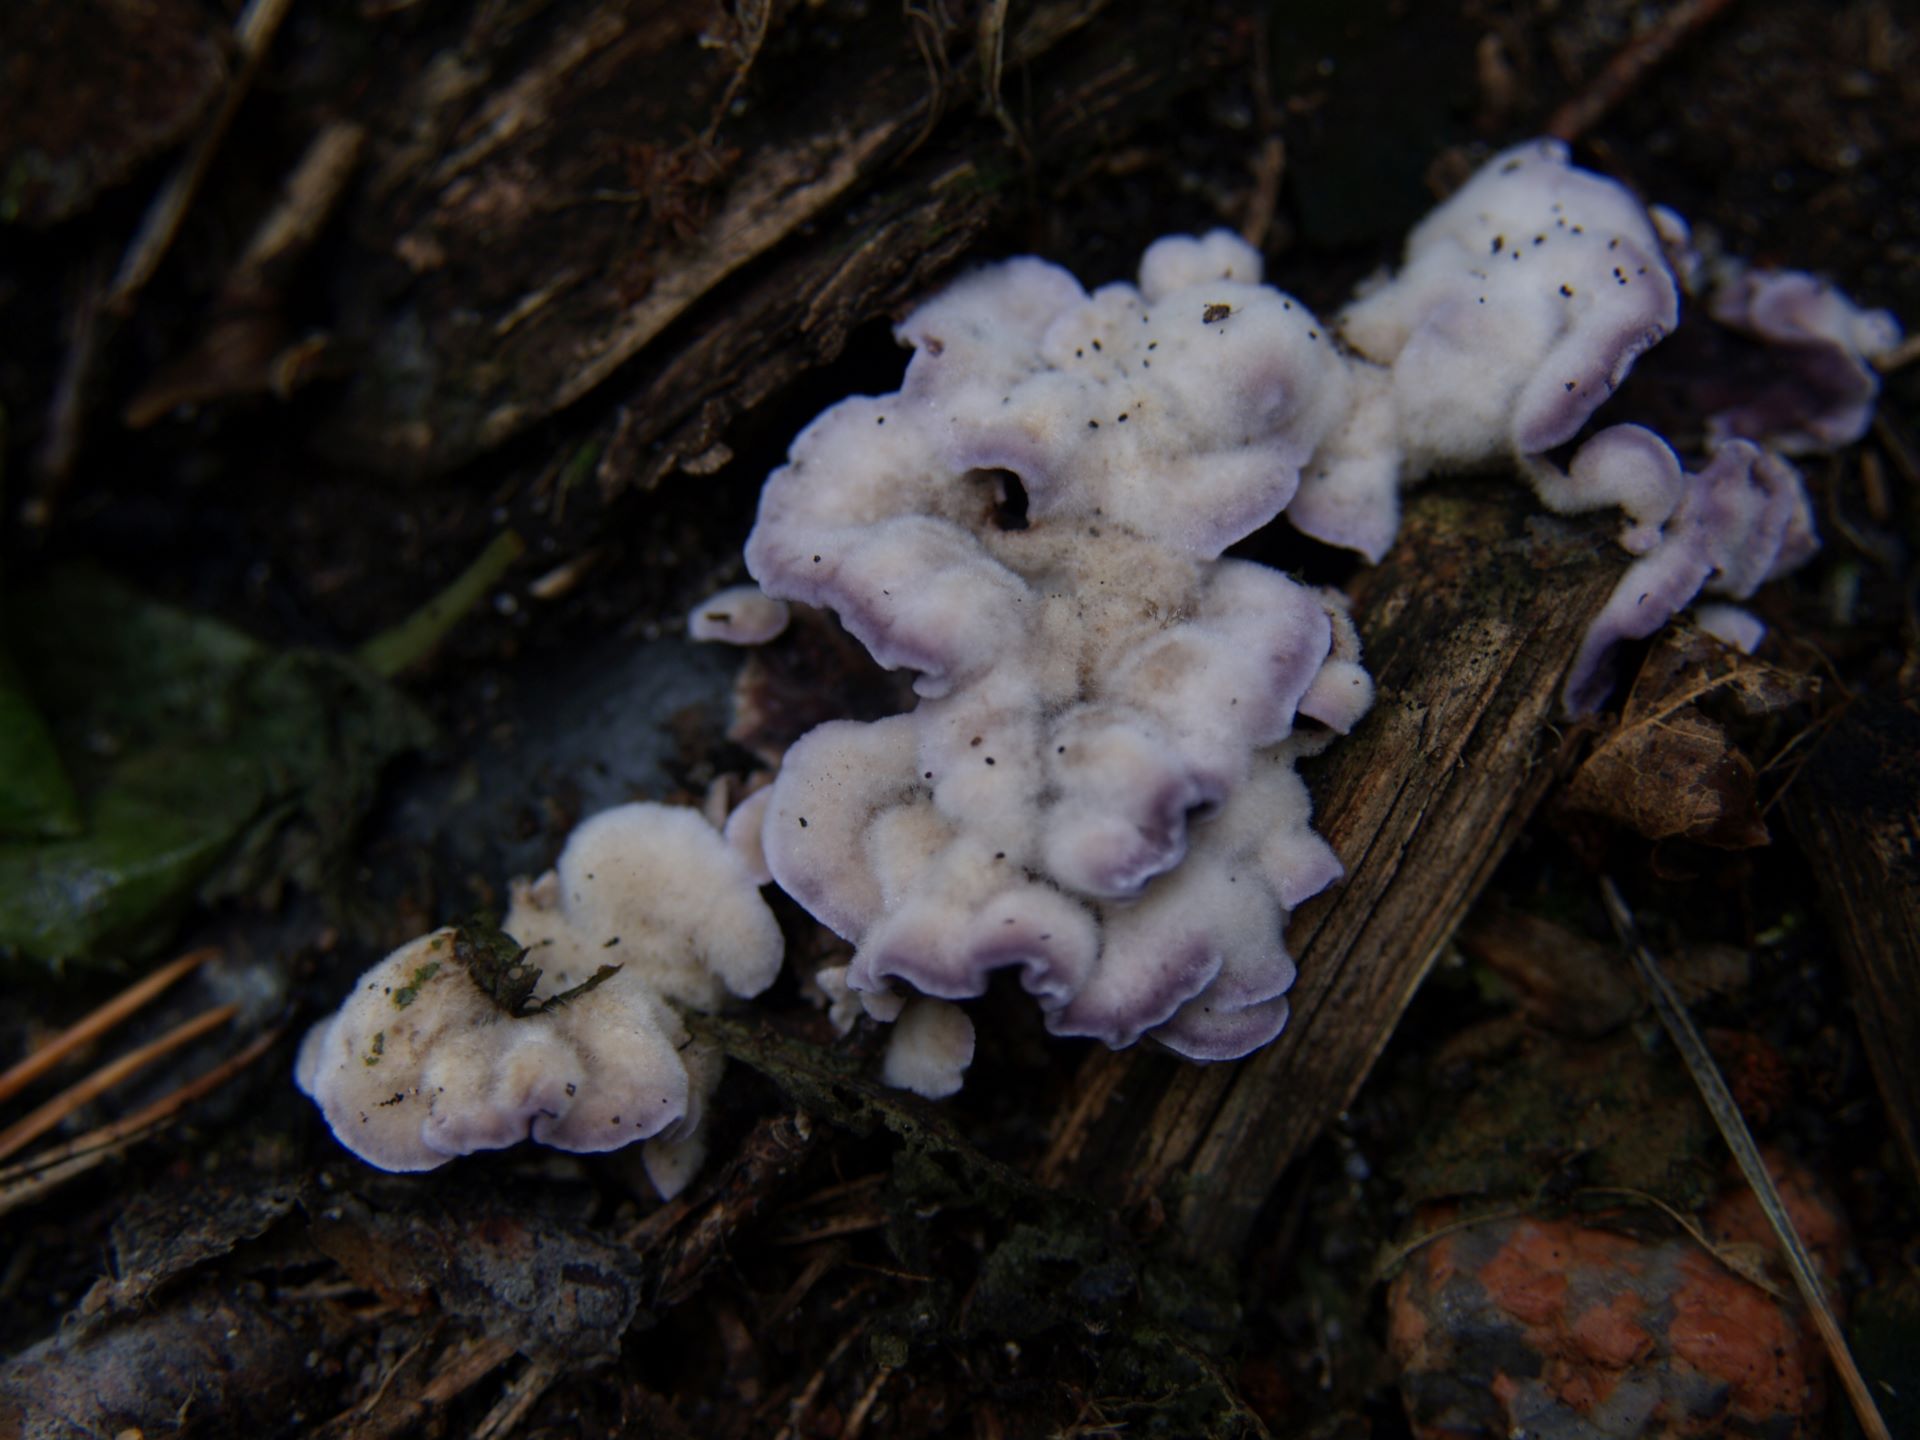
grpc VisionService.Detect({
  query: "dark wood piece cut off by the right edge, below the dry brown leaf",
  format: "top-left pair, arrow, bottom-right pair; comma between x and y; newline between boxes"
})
1786,695 -> 1920,1177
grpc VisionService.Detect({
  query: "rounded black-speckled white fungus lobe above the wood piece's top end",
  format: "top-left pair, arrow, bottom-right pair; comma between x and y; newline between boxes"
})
1286,140 -> 1680,561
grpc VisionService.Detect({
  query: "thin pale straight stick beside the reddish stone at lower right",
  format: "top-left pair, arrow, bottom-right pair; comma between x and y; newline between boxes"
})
1599,876 -> 1891,1440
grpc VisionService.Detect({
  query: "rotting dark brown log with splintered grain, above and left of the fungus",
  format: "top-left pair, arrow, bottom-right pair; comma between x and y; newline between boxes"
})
330,0 -> 1217,484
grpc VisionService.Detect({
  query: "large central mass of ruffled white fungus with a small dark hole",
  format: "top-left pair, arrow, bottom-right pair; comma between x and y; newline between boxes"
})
747,232 -> 1371,1058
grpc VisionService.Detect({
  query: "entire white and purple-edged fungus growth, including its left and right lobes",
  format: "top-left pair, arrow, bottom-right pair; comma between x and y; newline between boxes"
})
300,142 -> 1899,1192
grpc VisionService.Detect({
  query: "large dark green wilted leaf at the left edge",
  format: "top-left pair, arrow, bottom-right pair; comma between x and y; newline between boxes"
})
0,574 -> 430,966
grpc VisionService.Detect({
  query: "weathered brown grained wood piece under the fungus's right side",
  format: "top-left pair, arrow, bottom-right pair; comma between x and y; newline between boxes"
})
1044,484 -> 1619,1256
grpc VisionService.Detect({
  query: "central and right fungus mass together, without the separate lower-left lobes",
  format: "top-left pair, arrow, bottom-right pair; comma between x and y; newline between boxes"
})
721,140 -> 1891,1092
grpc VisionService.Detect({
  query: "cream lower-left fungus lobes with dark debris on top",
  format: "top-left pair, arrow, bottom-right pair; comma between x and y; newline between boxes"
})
296,804 -> 781,1192
